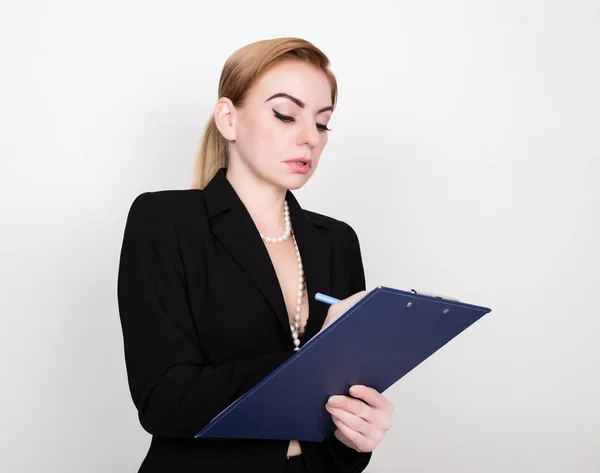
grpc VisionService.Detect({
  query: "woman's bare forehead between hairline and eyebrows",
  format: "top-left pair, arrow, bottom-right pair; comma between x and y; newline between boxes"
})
248,61 -> 332,109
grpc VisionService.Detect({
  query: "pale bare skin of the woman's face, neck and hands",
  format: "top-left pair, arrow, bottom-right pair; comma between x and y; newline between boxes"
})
214,61 -> 393,456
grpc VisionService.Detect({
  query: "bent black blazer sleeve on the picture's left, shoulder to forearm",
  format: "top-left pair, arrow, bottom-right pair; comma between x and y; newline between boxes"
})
117,192 -> 293,438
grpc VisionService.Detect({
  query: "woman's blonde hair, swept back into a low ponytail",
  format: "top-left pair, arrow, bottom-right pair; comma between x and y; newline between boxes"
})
192,38 -> 337,189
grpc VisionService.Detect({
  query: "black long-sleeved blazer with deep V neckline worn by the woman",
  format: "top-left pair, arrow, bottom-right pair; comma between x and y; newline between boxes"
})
117,169 -> 371,473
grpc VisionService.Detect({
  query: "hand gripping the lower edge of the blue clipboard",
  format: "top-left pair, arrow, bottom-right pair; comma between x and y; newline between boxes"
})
325,385 -> 394,452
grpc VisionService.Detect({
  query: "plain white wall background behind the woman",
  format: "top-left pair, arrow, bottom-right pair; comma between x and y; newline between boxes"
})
0,0 -> 600,473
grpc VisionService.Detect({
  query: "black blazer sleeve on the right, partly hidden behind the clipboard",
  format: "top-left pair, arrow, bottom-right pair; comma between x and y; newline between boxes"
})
322,224 -> 372,473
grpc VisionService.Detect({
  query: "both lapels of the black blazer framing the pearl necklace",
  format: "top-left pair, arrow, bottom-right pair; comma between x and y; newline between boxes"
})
204,168 -> 331,347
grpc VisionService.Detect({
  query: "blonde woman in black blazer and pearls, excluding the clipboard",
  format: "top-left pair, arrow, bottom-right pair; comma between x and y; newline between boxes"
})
118,38 -> 393,473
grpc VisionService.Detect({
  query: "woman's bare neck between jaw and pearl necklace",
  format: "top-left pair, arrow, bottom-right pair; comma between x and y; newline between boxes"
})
226,165 -> 286,235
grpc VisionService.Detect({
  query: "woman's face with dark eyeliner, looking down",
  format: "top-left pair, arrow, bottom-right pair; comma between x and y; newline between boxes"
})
219,61 -> 332,190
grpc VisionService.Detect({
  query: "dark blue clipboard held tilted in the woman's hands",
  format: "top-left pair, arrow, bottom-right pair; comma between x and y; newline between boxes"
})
194,286 -> 491,442
